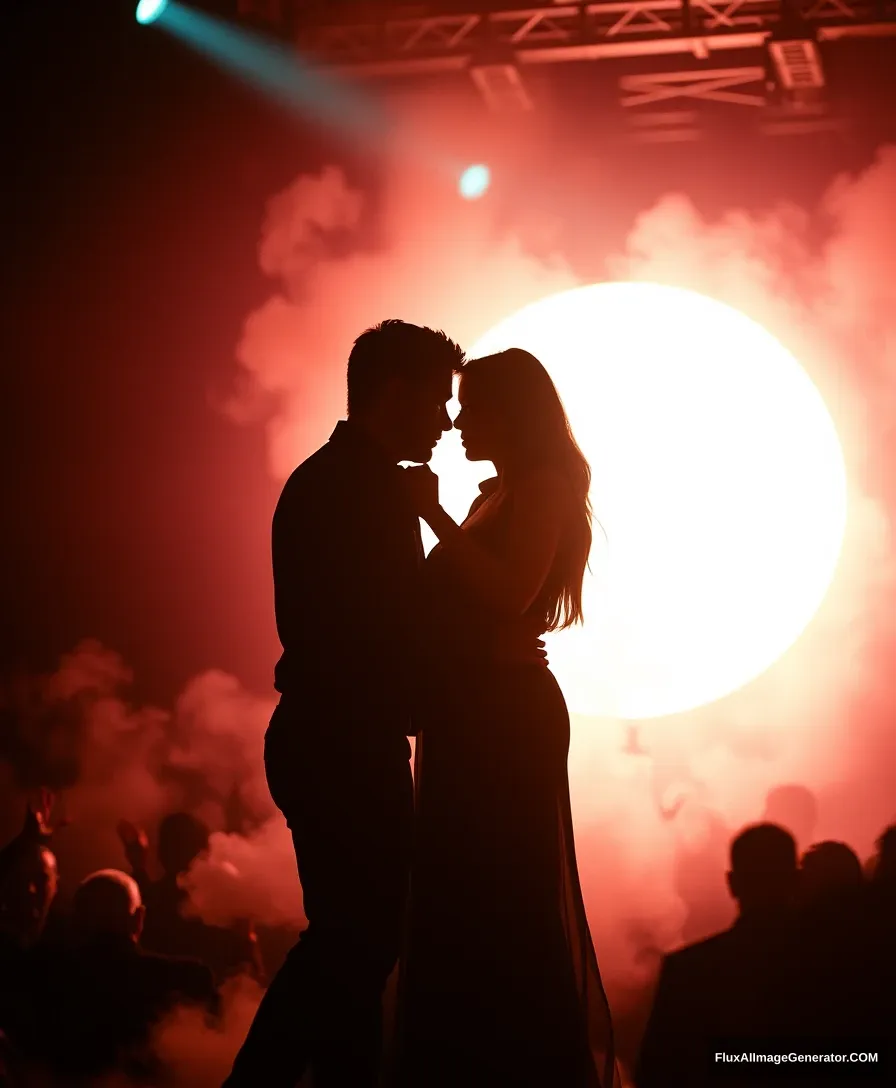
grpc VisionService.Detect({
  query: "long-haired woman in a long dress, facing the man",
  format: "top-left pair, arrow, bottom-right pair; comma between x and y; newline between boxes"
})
397,348 -> 617,1088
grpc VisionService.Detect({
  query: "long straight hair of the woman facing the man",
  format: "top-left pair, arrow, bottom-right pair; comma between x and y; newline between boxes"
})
460,347 -> 592,631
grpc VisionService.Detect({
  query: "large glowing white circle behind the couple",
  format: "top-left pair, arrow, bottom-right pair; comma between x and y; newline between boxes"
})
430,283 -> 846,719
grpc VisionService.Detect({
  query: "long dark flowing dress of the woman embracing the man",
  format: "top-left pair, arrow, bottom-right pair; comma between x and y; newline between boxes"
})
398,481 -> 617,1088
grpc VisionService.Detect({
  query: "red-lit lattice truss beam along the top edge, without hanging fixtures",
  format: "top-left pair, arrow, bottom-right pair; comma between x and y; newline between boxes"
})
284,0 -> 896,77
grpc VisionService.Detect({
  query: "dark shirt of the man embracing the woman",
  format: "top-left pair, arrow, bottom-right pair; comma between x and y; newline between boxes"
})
272,422 -> 423,757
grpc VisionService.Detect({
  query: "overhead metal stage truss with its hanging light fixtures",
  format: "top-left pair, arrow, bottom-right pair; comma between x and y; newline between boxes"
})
235,0 -> 896,134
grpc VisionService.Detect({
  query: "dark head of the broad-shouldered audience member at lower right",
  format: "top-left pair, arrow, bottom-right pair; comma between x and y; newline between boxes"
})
727,824 -> 797,917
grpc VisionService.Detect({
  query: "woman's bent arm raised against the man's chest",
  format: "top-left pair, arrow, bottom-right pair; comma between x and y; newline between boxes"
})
423,471 -> 567,618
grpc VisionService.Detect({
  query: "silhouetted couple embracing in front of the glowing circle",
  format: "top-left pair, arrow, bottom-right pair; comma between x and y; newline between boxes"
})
226,321 -> 614,1088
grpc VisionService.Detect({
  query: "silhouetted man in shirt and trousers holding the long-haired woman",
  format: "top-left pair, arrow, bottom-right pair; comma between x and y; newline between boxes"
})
225,321 -> 539,1088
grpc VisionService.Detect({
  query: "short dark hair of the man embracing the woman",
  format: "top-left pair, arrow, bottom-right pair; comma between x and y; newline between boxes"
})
348,318 -> 464,415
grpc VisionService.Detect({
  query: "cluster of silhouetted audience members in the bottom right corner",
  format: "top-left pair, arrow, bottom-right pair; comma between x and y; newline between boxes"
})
636,818 -> 896,1088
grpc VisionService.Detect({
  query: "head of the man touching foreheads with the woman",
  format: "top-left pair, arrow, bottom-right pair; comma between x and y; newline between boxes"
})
348,320 -> 463,463
